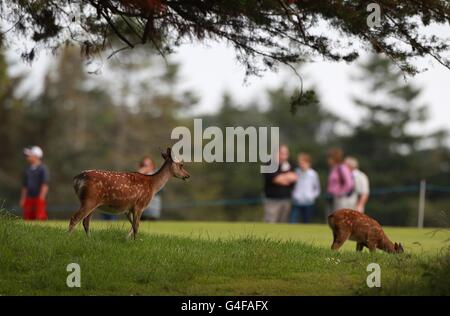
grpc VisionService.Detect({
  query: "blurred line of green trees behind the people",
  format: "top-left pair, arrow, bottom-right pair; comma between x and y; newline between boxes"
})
0,42 -> 450,225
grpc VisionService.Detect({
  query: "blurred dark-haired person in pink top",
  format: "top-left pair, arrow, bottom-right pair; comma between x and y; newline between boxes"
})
327,148 -> 355,213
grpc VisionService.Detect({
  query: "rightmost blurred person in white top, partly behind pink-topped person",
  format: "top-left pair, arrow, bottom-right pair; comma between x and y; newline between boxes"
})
345,157 -> 370,213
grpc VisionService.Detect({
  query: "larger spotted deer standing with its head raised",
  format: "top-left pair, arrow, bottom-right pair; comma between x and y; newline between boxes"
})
69,148 -> 190,238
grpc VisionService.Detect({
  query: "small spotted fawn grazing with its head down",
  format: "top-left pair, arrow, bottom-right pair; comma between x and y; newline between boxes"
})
328,209 -> 403,253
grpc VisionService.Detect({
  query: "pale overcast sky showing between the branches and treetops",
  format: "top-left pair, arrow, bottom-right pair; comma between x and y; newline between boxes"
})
10,39 -> 450,135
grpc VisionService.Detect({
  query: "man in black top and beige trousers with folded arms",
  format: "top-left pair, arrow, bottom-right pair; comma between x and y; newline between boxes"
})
264,145 -> 297,223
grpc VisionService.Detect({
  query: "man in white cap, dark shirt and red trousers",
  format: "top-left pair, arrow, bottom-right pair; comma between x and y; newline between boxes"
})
20,146 -> 49,220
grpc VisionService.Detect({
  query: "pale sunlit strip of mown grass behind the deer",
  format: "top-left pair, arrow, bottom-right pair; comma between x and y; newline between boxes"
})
39,221 -> 450,255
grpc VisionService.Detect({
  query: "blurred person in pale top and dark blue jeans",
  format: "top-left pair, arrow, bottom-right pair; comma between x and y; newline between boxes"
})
290,153 -> 320,223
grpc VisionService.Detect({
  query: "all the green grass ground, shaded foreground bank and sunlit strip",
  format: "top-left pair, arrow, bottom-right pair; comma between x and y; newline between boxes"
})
0,218 -> 449,295
